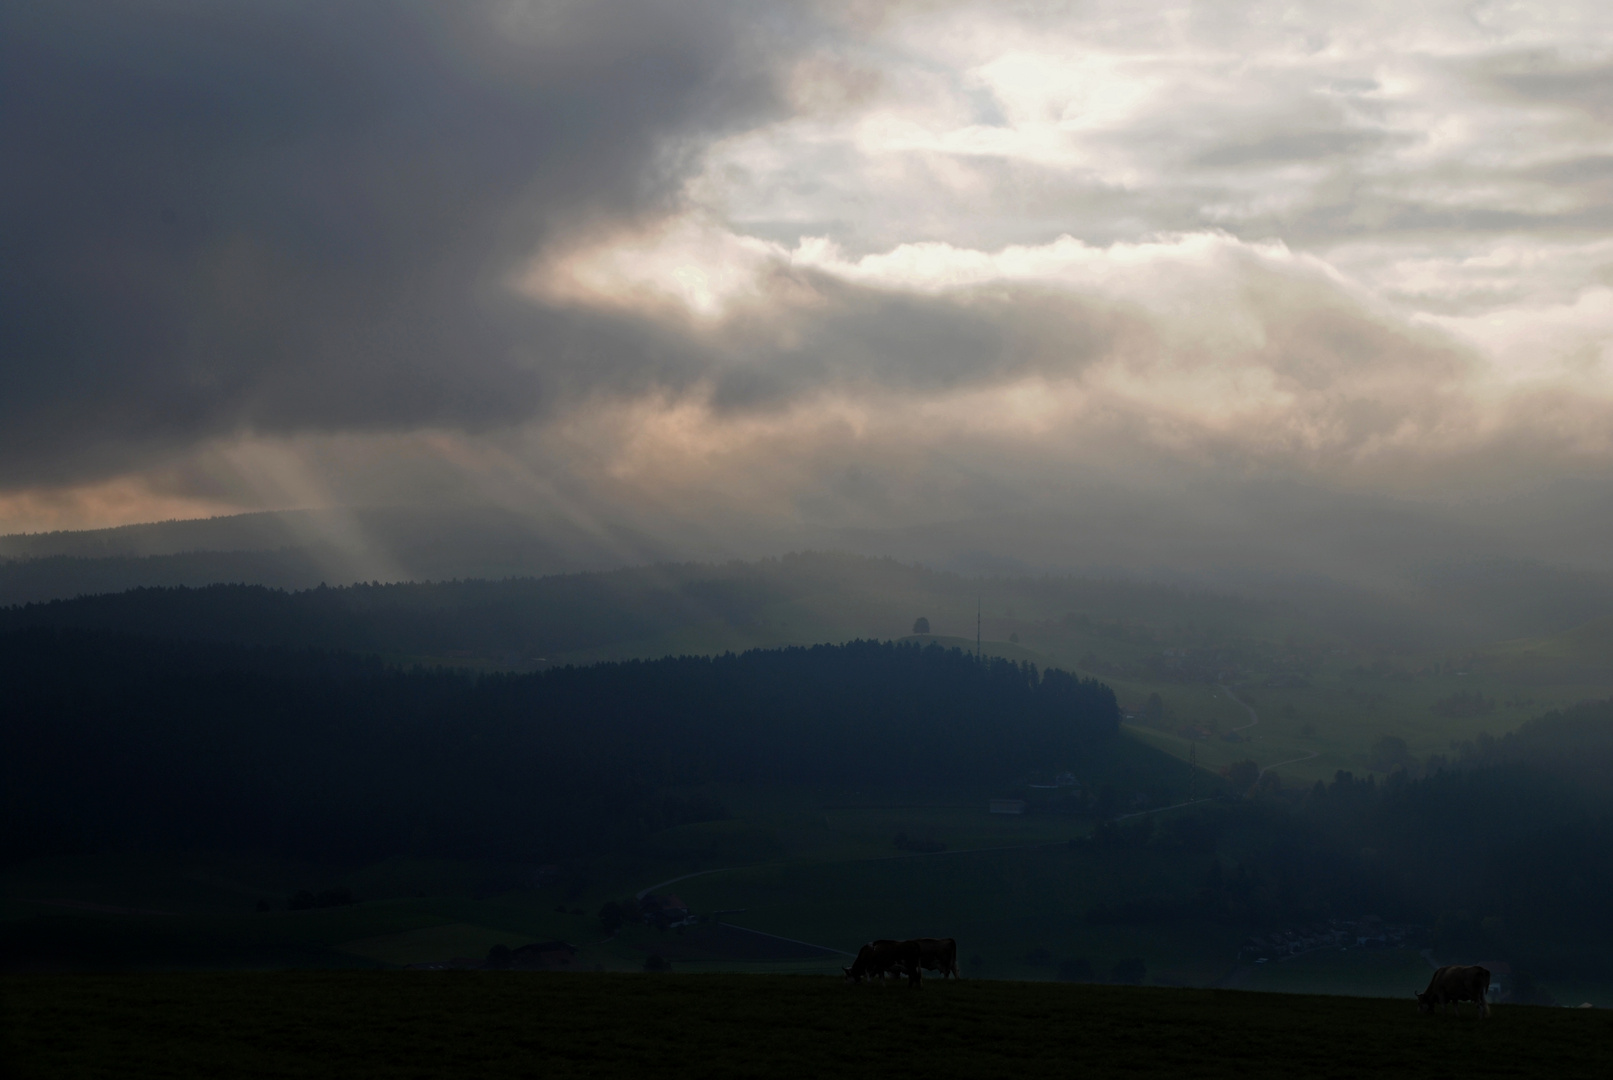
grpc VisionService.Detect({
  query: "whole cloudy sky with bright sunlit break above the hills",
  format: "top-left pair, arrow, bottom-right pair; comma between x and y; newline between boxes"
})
0,0 -> 1613,583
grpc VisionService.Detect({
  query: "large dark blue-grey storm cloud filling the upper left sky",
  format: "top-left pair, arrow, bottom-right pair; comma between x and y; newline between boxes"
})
0,0 -> 771,484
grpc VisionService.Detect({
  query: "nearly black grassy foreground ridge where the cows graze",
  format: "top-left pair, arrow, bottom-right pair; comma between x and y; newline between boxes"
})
0,972 -> 1613,1080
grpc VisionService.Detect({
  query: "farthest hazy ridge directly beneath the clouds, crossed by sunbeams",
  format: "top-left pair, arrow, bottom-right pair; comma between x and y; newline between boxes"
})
12,509 -> 1613,651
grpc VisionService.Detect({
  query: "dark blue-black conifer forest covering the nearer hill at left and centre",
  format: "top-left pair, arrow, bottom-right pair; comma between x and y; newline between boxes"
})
0,630 -> 1119,859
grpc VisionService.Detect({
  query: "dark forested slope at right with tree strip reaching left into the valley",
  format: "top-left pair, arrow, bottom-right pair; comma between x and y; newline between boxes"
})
1094,701 -> 1613,977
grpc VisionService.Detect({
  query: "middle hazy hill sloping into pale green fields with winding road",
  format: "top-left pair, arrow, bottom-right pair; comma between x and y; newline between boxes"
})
0,553 -> 1613,785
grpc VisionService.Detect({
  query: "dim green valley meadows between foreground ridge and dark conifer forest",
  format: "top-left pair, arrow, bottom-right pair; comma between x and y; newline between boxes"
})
15,770 -> 1613,1004
